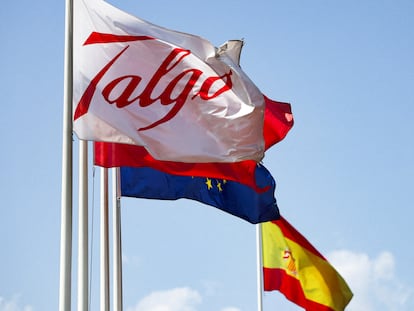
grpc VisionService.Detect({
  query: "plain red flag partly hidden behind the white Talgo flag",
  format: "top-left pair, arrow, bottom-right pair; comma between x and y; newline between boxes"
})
95,96 -> 293,191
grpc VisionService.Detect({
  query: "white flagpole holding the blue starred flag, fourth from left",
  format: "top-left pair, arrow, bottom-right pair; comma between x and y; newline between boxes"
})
112,167 -> 122,311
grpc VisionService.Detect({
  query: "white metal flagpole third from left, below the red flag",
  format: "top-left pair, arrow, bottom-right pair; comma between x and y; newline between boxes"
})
100,167 -> 109,311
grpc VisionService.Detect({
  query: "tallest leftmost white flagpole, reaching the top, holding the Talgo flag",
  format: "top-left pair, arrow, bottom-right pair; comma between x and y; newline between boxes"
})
59,0 -> 73,311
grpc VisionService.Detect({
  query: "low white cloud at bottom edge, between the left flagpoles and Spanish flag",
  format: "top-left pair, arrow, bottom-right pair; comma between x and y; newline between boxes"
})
127,287 -> 202,311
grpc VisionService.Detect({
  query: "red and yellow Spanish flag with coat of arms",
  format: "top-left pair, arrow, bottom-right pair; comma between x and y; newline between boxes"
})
261,217 -> 353,311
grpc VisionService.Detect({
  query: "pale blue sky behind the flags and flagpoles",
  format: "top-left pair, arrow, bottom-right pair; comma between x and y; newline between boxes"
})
0,0 -> 414,311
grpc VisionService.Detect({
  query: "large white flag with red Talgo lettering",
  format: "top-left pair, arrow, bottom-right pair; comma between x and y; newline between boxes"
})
73,0 -> 264,163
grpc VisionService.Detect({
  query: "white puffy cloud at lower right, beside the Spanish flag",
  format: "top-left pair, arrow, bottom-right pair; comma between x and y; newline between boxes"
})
327,250 -> 414,311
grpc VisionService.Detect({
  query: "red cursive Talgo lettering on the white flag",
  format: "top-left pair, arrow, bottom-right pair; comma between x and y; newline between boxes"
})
74,32 -> 233,131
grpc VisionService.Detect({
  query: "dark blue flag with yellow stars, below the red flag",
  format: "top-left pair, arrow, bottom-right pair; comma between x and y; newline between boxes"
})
121,165 -> 280,224
